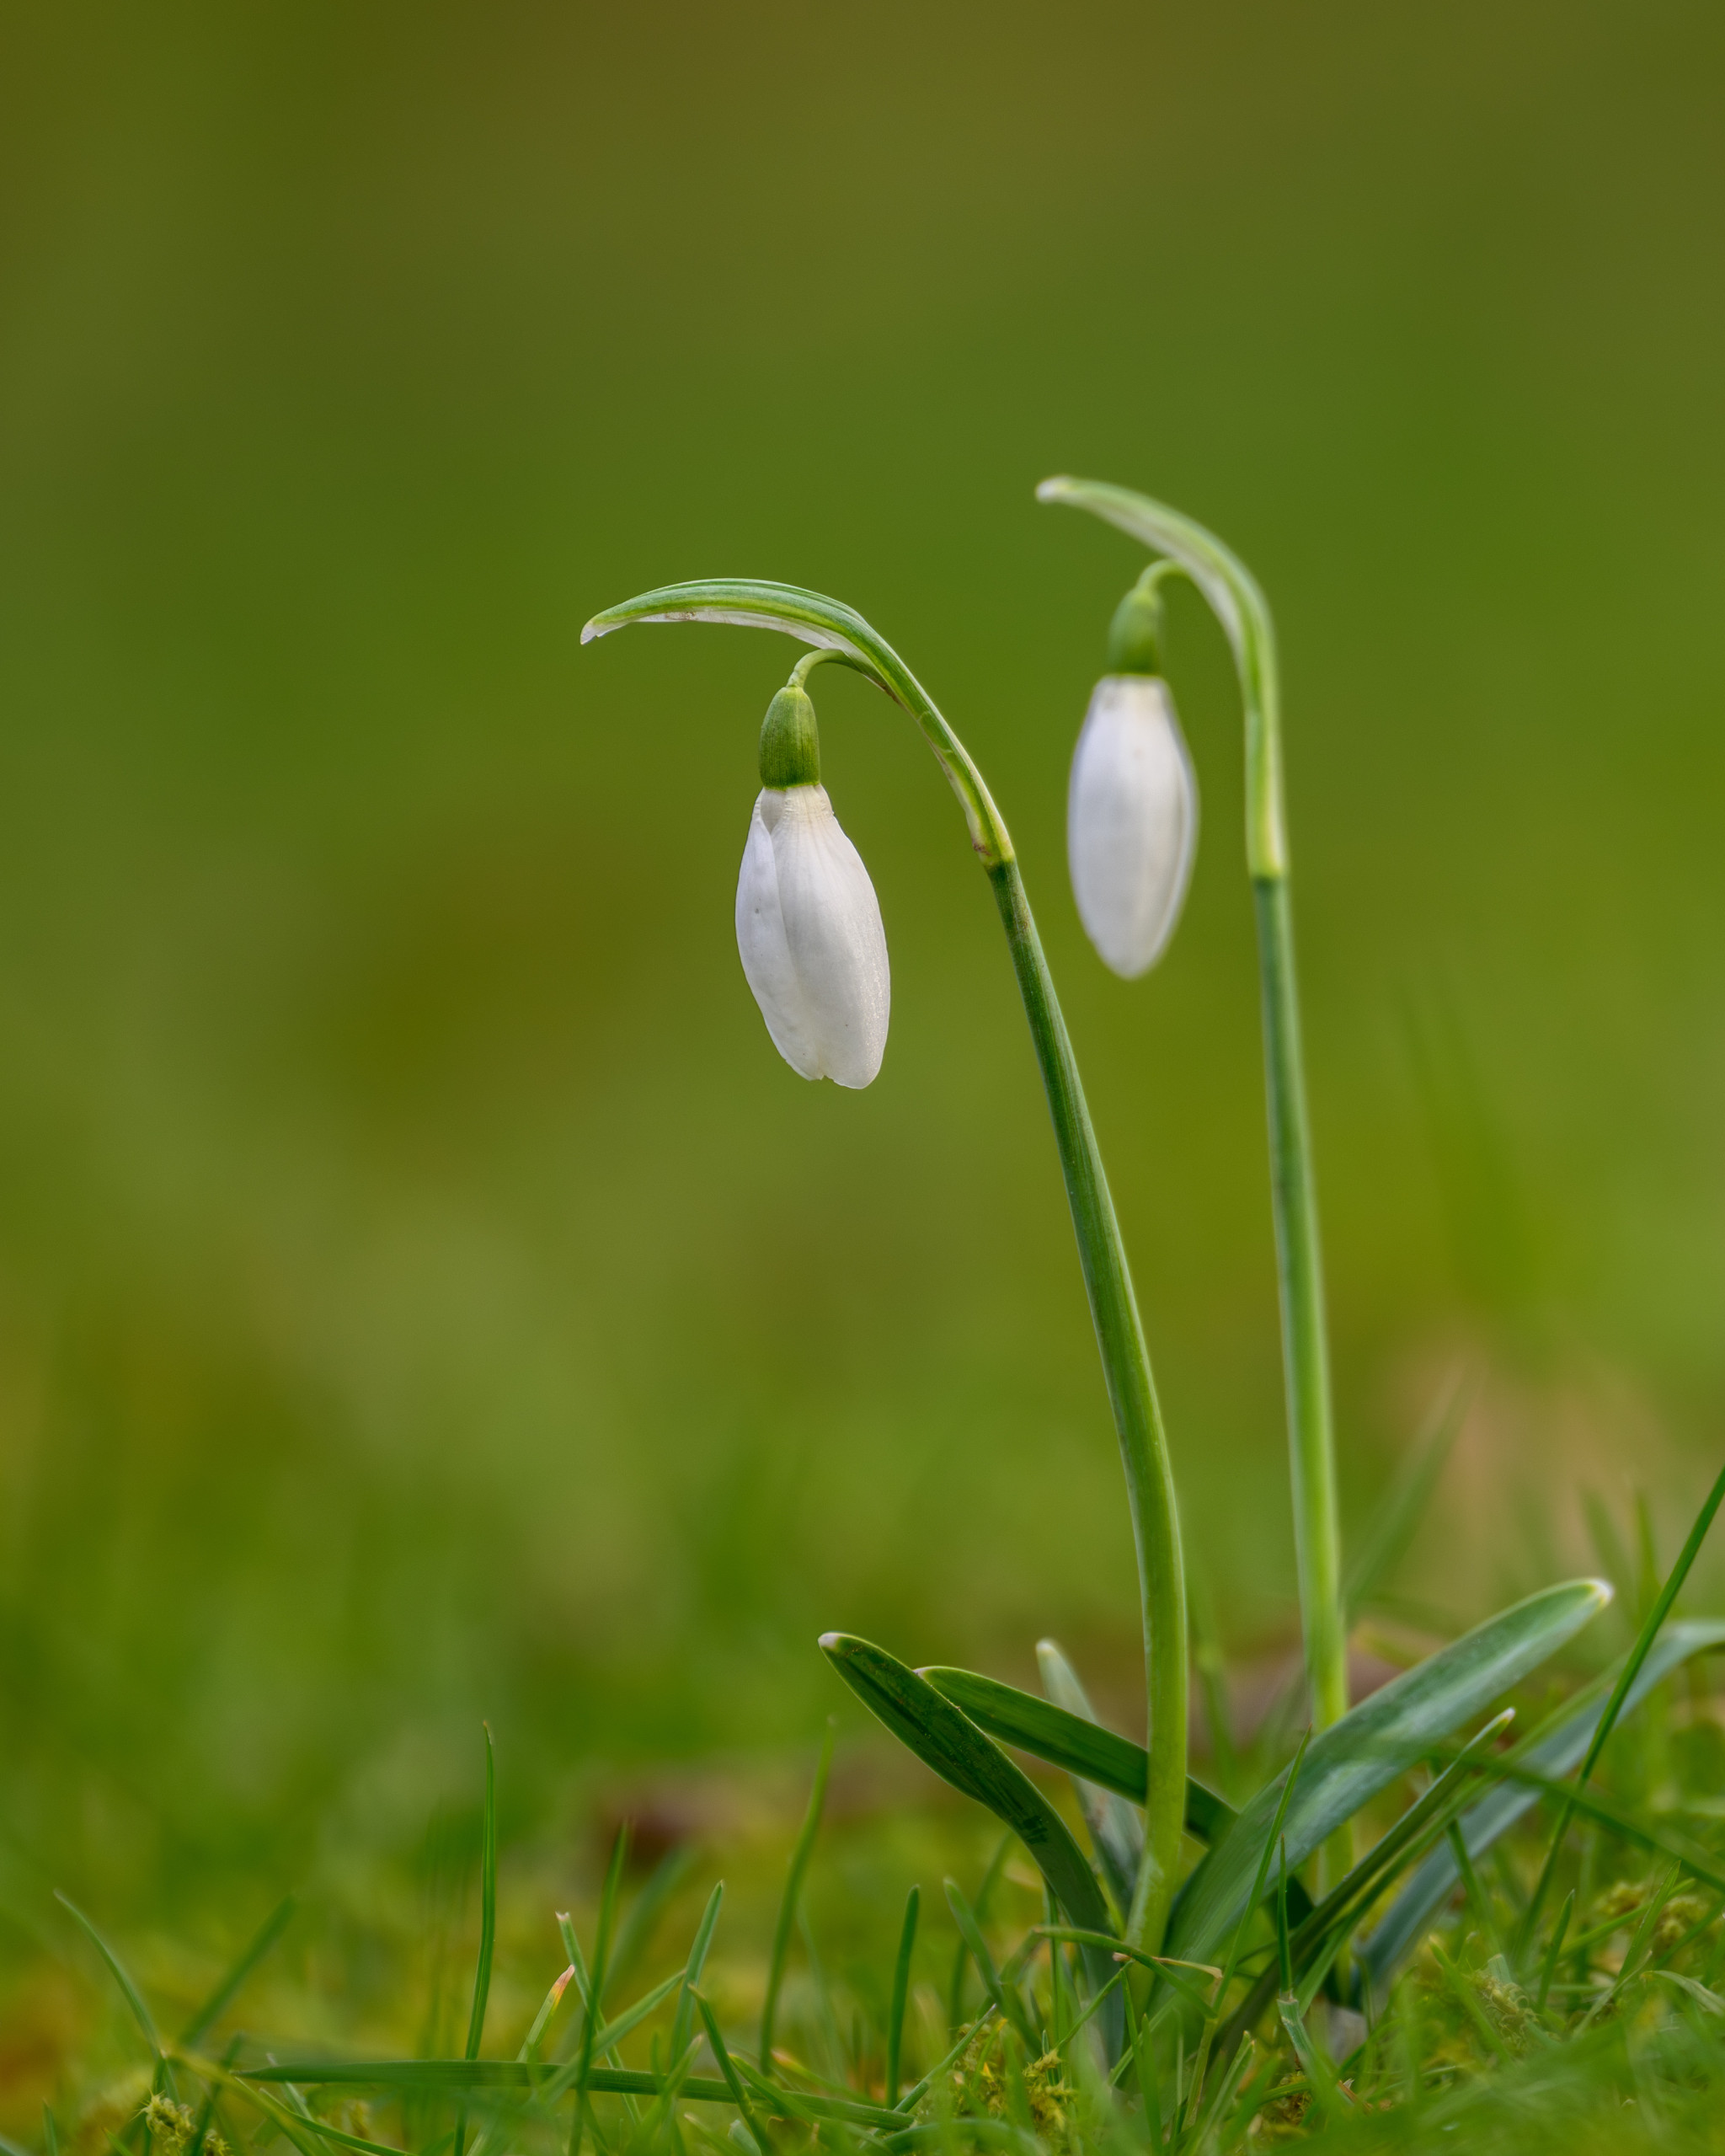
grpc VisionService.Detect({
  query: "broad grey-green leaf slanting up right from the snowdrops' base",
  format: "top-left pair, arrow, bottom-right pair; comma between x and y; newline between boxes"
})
1169,1581 -> 1610,1960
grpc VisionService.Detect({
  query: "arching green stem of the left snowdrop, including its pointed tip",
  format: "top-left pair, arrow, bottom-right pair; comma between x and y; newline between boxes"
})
582,580 -> 1186,1951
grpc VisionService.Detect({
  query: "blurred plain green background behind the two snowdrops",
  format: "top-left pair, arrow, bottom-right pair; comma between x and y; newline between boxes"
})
0,0 -> 1725,1983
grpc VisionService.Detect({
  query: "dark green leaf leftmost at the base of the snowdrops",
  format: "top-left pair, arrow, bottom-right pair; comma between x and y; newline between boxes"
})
821,1632 -> 1113,1940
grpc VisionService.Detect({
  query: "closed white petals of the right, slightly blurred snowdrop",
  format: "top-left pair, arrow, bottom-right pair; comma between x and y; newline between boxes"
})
1065,675 -> 1199,981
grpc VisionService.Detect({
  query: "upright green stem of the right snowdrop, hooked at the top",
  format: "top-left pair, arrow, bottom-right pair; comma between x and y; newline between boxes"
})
1037,479 -> 1348,1729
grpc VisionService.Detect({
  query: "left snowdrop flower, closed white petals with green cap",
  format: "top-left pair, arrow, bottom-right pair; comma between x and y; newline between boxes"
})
738,682 -> 890,1087
